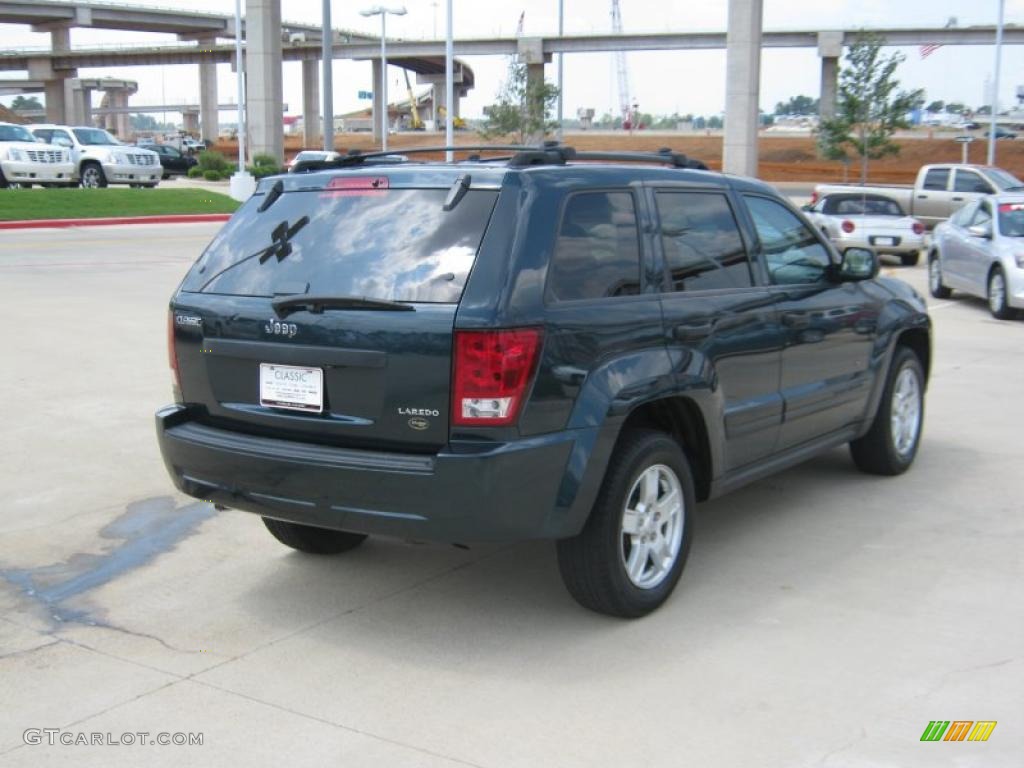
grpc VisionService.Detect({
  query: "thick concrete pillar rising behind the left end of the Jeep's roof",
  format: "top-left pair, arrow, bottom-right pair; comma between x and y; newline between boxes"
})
246,0 -> 285,163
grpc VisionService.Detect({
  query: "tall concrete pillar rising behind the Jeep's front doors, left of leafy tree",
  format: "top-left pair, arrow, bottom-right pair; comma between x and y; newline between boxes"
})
722,0 -> 763,176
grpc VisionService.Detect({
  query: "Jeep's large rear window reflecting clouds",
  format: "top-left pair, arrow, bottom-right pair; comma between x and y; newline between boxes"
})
182,187 -> 498,304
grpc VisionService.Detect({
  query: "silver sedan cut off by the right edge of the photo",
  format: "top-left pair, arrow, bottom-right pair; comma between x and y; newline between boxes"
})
928,194 -> 1024,319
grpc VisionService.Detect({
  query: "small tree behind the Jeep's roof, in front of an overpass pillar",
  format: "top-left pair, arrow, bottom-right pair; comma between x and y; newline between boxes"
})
480,61 -> 558,143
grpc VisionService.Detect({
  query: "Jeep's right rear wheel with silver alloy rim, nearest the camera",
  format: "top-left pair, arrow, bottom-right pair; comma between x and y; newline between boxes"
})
557,430 -> 696,618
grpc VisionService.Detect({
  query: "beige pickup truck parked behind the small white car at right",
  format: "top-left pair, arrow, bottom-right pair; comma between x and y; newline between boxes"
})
811,163 -> 1024,227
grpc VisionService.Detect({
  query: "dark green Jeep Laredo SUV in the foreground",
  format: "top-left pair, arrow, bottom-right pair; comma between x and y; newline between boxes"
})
157,146 -> 931,616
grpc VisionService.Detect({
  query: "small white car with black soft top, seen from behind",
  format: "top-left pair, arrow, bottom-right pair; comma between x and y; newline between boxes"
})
805,193 -> 925,266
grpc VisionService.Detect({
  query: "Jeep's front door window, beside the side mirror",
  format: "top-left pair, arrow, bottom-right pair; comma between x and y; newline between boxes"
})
743,196 -> 831,285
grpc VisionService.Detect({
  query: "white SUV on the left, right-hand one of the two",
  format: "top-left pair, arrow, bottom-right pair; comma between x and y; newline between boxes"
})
28,124 -> 163,187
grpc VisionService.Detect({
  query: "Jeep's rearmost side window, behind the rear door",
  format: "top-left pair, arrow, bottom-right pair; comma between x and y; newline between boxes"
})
546,191 -> 640,301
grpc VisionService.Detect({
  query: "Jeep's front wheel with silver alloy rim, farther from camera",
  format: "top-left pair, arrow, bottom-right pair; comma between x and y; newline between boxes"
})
850,347 -> 925,475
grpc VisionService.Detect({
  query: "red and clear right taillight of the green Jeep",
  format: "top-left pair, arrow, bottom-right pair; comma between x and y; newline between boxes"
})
452,328 -> 543,427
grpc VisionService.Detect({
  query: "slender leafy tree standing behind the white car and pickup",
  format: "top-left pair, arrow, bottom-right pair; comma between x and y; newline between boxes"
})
818,33 -> 924,183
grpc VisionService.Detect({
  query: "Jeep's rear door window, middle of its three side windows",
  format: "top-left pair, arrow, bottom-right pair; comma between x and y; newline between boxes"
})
657,191 -> 753,291
